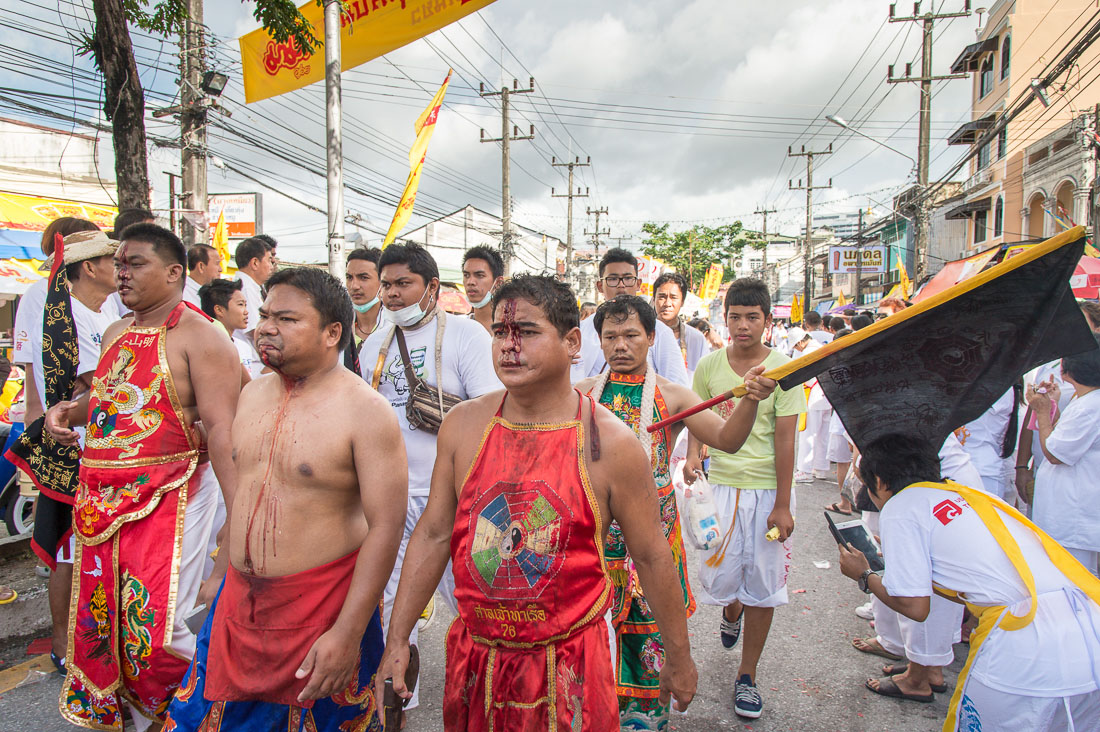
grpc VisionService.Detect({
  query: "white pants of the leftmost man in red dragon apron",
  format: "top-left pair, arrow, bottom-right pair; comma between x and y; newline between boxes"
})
130,470 -> 221,732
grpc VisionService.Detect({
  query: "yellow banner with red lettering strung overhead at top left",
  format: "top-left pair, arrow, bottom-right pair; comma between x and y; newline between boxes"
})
240,0 -> 493,103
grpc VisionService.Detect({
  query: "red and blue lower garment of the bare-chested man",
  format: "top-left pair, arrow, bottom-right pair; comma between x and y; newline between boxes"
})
164,551 -> 383,732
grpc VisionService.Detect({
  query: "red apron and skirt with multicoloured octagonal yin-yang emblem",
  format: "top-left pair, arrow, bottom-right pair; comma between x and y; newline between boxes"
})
443,395 -> 618,732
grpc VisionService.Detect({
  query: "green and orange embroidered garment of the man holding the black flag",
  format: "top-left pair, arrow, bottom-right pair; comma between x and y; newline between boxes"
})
593,369 -> 695,730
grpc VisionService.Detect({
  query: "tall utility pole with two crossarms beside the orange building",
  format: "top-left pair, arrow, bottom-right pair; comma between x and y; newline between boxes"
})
887,0 -> 970,282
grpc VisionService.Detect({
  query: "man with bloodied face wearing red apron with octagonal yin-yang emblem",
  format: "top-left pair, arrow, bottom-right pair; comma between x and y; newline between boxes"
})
377,275 -> 696,732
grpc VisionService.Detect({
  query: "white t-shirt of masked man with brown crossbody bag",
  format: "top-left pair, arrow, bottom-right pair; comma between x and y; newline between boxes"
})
359,314 -> 504,496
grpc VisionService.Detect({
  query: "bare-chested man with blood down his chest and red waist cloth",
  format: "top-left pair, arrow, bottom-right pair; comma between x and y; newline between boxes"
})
169,267 -> 408,731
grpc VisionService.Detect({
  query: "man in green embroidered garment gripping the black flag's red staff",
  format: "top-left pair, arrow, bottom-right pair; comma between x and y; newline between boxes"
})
576,295 -> 776,730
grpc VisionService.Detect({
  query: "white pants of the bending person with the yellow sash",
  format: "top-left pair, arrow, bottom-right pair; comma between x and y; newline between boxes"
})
955,678 -> 1100,732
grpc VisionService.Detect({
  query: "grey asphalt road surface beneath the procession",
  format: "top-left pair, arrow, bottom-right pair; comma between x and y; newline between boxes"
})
0,481 -> 966,732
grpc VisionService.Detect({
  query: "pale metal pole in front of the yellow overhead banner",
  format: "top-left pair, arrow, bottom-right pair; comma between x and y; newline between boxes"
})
325,0 -> 345,282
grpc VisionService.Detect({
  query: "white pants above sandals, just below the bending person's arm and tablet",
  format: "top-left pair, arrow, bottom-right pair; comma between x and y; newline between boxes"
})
871,594 -> 963,666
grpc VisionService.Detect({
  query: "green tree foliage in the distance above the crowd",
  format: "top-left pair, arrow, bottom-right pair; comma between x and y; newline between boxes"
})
641,221 -> 763,289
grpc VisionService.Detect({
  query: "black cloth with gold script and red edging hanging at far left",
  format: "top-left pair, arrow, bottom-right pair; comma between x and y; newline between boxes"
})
4,234 -> 80,569
